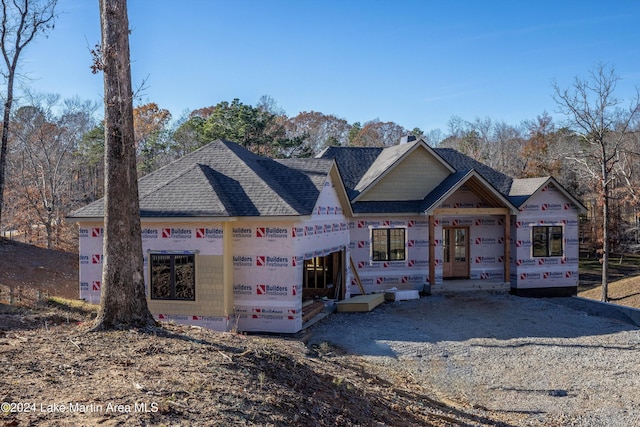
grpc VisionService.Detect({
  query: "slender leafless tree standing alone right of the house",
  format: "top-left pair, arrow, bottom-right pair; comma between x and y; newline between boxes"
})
553,64 -> 640,301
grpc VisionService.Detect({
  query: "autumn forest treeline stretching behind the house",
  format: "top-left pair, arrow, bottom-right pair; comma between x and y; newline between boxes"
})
1,79 -> 640,251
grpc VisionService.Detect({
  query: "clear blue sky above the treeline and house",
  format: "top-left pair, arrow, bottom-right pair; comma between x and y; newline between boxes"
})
21,0 -> 640,132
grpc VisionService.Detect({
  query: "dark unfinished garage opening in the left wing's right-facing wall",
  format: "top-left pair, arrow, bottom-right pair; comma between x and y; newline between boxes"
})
302,251 -> 345,300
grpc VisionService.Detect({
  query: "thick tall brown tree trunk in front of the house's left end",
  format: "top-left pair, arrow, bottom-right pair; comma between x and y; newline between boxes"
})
94,0 -> 155,330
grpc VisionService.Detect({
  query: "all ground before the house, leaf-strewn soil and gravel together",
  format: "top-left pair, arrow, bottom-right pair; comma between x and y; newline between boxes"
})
0,242 -> 640,427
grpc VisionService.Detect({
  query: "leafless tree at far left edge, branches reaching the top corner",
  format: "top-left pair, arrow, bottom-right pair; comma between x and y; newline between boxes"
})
0,0 -> 57,231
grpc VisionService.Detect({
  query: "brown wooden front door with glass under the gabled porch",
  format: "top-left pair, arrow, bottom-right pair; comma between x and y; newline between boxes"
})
442,227 -> 469,279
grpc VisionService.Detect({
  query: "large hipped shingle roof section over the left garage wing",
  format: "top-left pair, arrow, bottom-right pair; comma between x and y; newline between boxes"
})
71,140 -> 333,218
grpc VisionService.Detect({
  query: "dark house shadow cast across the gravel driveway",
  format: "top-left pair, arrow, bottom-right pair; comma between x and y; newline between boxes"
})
309,292 -> 638,357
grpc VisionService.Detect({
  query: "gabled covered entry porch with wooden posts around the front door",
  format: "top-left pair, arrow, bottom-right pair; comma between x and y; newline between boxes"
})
425,171 -> 518,293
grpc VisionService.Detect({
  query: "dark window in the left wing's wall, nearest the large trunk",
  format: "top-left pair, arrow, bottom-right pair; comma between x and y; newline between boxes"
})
149,254 -> 196,301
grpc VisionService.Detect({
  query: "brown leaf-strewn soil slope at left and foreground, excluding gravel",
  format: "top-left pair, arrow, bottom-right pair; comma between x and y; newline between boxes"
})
0,240 -> 513,426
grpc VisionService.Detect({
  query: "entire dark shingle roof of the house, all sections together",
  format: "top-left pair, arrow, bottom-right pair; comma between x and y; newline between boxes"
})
71,140 -> 564,218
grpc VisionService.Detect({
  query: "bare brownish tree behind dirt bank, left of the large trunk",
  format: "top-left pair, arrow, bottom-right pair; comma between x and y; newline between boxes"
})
5,95 -> 95,249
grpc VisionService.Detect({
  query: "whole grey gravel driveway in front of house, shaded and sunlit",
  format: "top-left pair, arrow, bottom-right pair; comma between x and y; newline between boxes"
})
309,293 -> 640,427
